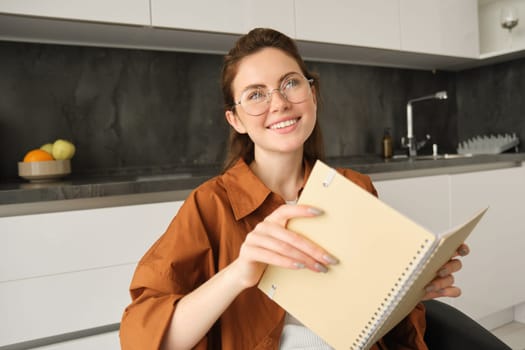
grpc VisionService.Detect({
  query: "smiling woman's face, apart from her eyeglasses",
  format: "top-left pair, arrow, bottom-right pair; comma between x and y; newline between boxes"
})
226,48 -> 317,158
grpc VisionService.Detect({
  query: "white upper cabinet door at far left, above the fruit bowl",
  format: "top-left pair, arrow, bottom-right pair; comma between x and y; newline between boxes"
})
0,0 -> 150,26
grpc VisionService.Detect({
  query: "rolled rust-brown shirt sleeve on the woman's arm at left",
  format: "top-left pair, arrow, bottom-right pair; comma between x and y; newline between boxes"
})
120,193 -> 215,350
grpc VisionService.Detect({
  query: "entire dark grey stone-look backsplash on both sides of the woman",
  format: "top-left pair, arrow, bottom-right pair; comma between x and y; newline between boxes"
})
0,42 -> 525,180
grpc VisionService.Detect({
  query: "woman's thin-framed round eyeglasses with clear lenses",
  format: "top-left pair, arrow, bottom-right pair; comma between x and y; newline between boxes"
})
232,73 -> 314,116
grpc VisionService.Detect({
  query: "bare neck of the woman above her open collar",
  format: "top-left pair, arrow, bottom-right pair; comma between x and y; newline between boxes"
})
250,149 -> 304,201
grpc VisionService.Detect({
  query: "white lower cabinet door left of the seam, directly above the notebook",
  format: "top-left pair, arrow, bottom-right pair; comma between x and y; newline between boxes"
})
374,175 -> 450,232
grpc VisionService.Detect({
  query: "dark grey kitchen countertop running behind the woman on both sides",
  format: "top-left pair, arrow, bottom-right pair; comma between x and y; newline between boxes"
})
0,153 -> 525,217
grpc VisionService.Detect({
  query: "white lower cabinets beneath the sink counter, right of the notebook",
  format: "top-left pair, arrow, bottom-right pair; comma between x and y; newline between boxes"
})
374,166 -> 525,325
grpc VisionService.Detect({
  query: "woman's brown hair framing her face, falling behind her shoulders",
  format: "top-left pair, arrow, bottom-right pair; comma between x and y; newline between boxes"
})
218,28 -> 324,171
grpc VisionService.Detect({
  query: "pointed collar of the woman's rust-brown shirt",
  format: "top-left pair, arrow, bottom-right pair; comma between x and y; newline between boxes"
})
222,158 -> 312,220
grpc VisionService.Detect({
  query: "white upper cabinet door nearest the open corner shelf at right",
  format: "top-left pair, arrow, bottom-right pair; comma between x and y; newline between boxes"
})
399,0 -> 479,58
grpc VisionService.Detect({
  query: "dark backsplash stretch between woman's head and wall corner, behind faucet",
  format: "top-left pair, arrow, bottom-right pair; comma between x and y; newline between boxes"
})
309,62 -> 457,156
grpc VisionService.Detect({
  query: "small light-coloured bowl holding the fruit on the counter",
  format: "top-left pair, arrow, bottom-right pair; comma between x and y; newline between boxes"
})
18,159 -> 71,182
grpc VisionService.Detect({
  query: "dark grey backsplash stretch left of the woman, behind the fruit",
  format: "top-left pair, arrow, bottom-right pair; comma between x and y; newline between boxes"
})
0,43 -> 228,178
